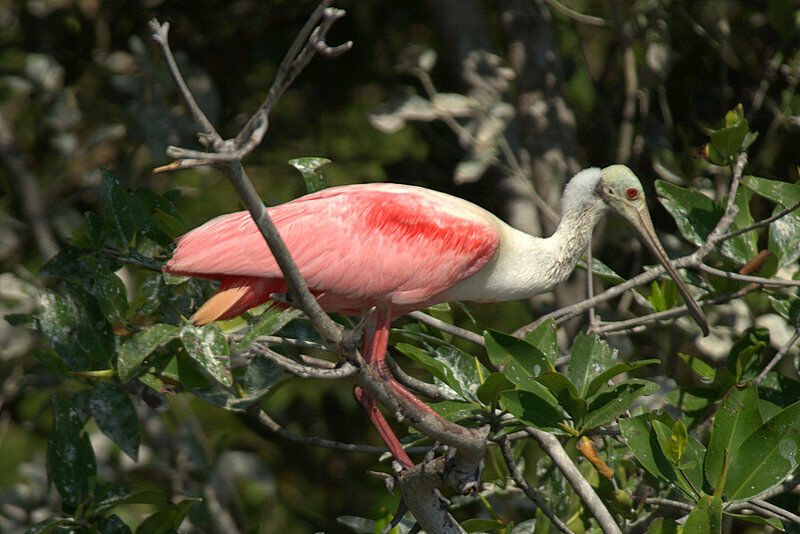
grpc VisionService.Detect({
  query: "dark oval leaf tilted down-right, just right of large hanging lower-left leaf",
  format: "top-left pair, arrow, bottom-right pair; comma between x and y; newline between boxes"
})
89,382 -> 140,461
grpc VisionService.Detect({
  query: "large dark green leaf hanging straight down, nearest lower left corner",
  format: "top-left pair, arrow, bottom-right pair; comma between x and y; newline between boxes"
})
47,395 -> 97,507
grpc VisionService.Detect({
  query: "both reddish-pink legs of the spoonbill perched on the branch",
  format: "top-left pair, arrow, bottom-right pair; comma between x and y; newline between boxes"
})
353,310 -> 438,469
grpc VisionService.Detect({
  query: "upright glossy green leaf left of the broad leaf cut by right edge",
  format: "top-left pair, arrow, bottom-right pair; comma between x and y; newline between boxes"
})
705,382 -> 762,490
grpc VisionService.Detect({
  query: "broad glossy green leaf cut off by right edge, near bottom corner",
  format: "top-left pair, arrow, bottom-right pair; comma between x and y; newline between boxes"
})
725,401 -> 800,501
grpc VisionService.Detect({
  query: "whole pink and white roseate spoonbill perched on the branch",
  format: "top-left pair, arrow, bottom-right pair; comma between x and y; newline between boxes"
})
164,165 -> 708,467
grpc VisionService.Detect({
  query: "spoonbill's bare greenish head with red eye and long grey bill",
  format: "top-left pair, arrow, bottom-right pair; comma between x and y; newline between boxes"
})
594,165 -> 709,335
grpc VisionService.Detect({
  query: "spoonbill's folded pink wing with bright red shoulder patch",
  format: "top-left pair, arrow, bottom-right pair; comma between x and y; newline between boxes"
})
165,184 -> 498,320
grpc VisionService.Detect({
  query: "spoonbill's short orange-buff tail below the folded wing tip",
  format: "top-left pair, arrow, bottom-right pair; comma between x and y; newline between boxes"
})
191,277 -> 286,326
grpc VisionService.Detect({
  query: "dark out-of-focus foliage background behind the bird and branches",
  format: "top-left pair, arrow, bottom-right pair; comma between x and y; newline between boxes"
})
0,0 -> 800,533
